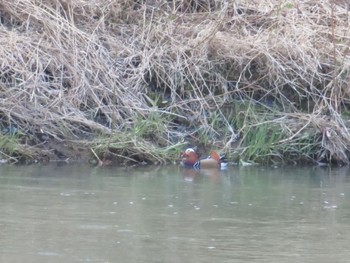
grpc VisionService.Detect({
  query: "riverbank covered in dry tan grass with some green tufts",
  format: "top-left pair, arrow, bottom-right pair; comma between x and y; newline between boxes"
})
0,0 -> 350,164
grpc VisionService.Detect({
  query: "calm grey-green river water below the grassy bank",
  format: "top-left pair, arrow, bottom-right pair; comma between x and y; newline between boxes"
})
0,165 -> 350,263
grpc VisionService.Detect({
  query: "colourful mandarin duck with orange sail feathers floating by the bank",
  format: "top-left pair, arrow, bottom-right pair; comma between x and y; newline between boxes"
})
180,148 -> 227,169
